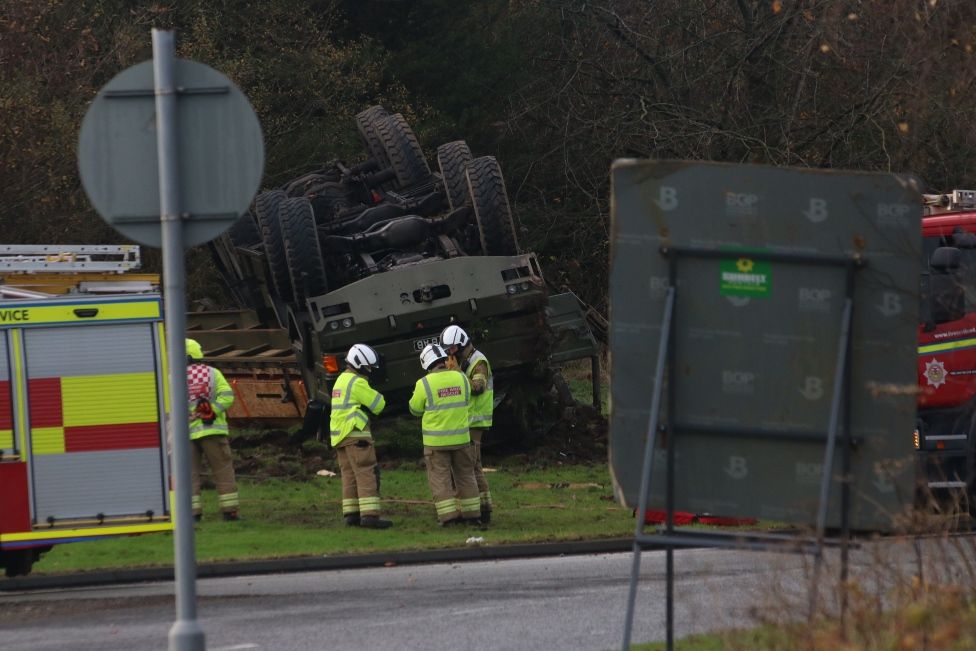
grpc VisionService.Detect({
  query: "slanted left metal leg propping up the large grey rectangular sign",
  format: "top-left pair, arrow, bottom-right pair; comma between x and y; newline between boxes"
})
620,286 -> 674,651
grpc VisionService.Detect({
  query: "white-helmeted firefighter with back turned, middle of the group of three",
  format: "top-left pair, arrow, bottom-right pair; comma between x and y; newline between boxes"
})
410,344 -> 481,526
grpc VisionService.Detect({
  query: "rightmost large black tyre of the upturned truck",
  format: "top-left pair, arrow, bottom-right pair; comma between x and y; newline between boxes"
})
466,156 -> 519,255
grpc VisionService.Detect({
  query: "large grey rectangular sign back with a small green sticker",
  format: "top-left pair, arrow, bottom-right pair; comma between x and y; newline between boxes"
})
610,160 -> 922,529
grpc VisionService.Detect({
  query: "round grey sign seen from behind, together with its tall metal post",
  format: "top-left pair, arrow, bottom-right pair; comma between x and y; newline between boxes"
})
78,29 -> 264,651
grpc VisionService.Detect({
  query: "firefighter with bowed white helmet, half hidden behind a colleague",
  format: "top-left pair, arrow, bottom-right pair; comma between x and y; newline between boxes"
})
441,325 -> 495,524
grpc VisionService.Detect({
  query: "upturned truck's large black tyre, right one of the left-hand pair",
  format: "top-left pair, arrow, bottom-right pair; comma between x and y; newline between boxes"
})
280,197 -> 329,307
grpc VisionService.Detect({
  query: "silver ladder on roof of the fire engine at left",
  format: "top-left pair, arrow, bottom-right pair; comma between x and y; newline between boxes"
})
0,244 -> 140,273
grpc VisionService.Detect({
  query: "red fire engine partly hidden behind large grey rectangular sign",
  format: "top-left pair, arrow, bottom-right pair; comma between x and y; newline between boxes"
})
914,190 -> 976,509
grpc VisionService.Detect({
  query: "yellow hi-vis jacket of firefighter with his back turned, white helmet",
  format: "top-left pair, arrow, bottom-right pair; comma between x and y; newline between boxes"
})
410,369 -> 471,448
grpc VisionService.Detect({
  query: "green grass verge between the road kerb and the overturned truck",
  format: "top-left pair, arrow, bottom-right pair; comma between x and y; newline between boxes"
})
34,464 -> 634,574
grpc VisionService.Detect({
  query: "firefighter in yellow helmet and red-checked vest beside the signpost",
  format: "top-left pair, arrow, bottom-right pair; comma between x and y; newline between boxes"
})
186,339 -> 240,520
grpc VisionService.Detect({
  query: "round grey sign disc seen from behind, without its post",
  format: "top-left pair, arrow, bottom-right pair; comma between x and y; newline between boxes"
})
78,59 -> 264,247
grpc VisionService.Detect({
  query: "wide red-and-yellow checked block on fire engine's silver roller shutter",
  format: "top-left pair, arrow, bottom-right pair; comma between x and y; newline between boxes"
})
29,372 -> 160,454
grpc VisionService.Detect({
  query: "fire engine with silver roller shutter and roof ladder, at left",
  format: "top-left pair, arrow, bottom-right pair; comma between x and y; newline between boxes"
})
0,246 -> 173,576
